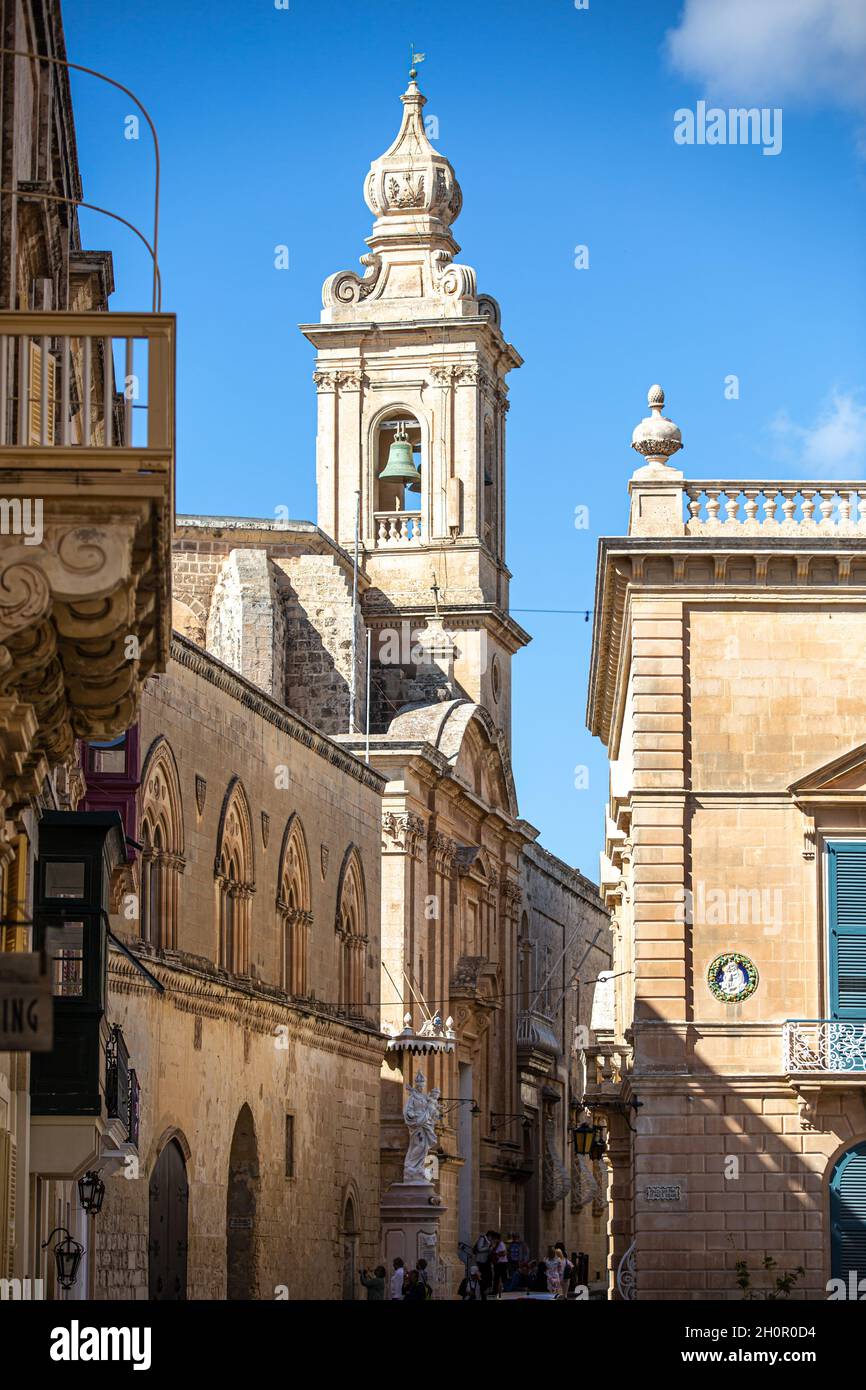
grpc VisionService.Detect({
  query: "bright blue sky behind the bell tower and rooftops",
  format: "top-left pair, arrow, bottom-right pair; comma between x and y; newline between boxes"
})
64,0 -> 866,877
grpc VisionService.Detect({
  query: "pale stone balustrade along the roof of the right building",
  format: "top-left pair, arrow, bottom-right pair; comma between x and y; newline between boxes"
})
681,480 -> 866,535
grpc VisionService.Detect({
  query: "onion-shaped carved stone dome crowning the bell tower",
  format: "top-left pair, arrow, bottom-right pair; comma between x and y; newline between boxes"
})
364,79 -> 463,236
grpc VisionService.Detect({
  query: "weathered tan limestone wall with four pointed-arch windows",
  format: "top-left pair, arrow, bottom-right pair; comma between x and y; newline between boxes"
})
95,639 -> 384,1298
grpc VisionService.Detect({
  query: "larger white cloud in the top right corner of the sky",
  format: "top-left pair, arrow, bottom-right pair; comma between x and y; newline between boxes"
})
666,0 -> 866,110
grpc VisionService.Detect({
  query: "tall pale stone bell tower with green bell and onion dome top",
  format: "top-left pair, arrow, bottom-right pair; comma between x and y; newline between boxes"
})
302,71 -> 530,745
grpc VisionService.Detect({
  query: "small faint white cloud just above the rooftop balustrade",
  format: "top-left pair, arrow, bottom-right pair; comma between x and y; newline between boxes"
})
769,391 -> 866,480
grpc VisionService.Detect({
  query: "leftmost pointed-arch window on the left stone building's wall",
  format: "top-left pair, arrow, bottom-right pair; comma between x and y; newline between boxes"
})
139,735 -> 185,951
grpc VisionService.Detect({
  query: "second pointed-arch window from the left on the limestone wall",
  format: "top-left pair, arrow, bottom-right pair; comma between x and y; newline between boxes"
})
214,777 -> 256,974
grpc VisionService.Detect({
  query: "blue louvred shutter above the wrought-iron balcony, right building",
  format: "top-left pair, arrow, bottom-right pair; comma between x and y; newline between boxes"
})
827,840 -> 866,1019
